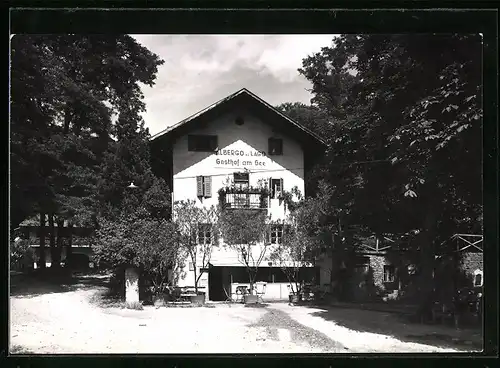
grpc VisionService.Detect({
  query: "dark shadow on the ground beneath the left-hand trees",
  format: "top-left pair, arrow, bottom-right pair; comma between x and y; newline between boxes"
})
10,271 -> 109,298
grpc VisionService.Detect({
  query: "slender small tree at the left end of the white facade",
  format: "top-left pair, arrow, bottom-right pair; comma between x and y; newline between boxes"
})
173,200 -> 219,293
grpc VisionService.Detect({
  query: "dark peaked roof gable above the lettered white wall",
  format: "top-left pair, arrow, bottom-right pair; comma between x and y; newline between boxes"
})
151,88 -> 326,146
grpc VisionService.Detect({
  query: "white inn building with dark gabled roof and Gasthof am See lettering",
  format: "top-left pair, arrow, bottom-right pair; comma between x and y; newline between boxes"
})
151,89 -> 324,300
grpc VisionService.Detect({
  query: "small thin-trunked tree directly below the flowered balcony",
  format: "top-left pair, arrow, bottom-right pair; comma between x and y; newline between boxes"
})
219,209 -> 270,294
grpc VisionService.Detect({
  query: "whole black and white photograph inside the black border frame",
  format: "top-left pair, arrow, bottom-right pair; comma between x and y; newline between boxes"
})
9,20 -> 489,355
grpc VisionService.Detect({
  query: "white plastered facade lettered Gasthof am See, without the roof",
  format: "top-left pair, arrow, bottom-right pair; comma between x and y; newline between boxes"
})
152,87 -> 324,299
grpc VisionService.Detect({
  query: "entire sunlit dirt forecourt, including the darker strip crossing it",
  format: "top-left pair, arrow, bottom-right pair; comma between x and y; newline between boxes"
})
10,277 -> 478,354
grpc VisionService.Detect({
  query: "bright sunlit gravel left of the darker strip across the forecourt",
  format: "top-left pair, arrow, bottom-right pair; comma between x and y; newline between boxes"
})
10,278 -> 323,354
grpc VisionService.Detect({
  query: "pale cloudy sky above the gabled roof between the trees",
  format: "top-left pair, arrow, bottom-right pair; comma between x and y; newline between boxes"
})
132,35 -> 335,135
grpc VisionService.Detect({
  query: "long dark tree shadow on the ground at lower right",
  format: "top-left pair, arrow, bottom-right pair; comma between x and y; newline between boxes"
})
305,305 -> 483,351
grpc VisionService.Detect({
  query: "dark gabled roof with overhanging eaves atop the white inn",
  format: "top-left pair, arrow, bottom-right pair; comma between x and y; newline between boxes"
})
151,88 -> 326,146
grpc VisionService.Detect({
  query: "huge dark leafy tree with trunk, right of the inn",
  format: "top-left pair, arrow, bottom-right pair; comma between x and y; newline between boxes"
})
300,35 -> 482,310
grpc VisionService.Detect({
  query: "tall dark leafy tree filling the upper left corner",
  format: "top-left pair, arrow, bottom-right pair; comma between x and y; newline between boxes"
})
11,35 -> 163,250
